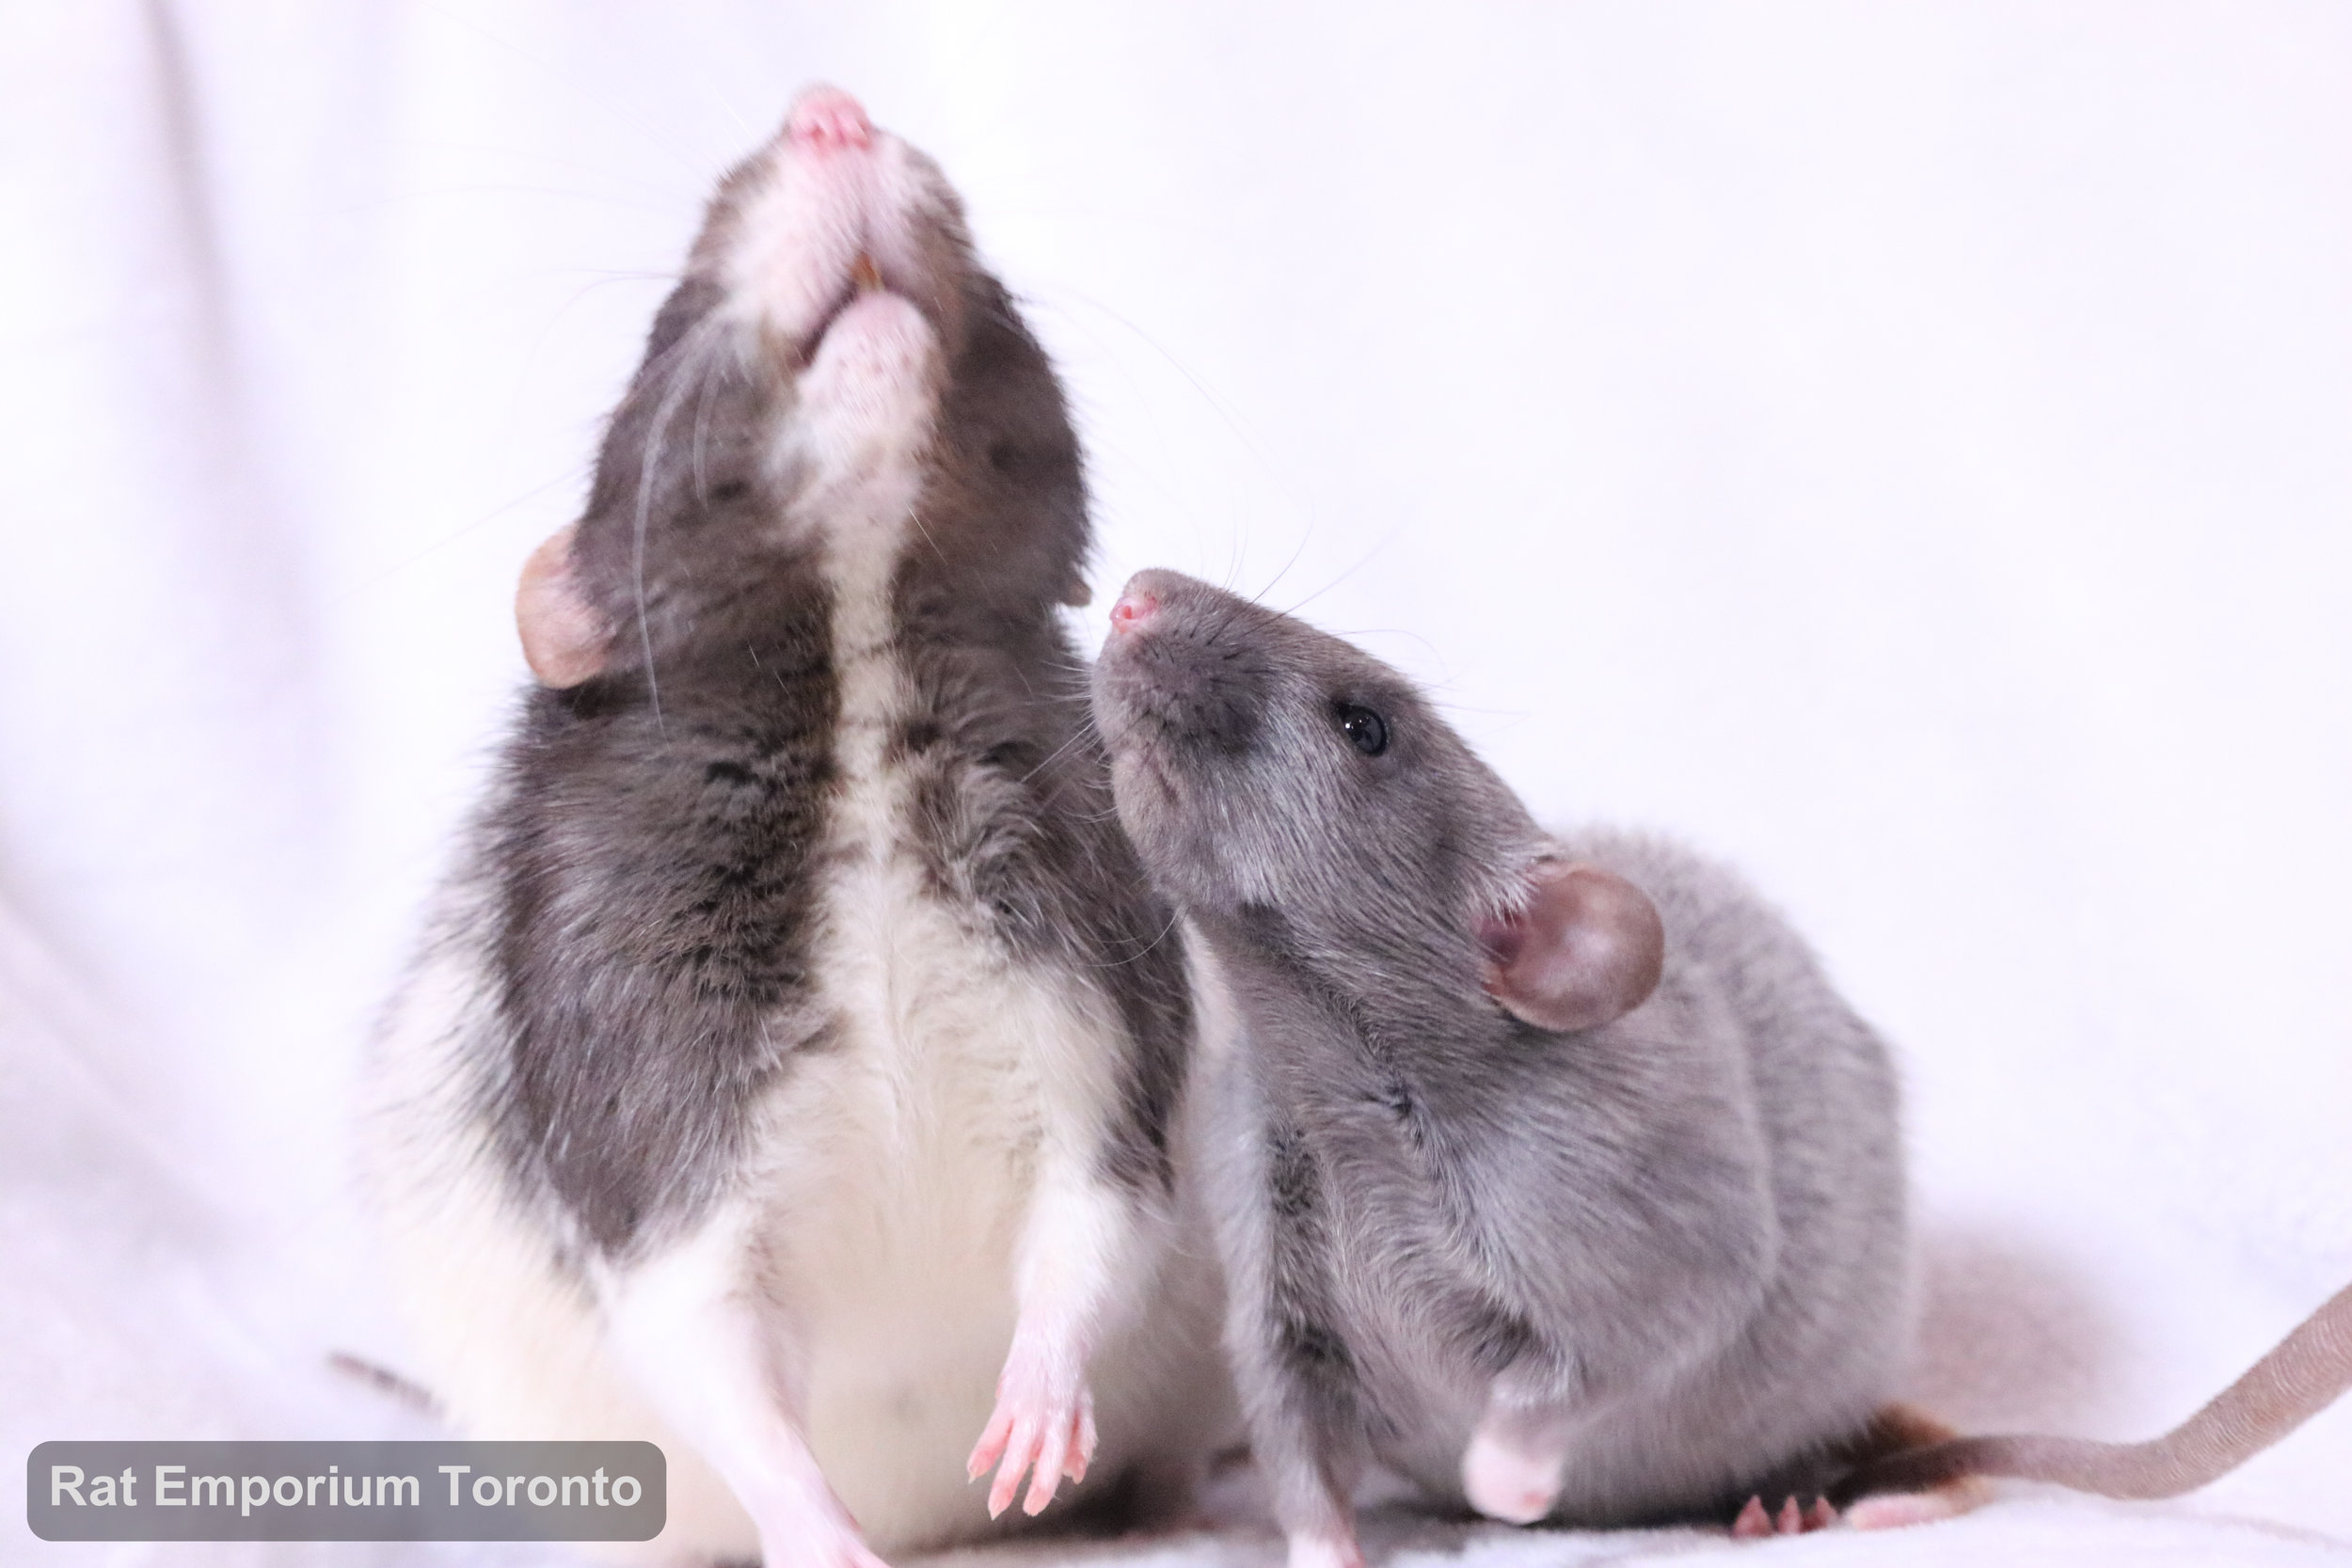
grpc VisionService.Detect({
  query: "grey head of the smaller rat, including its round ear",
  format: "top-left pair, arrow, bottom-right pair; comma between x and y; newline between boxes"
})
1094,571 -> 1663,1030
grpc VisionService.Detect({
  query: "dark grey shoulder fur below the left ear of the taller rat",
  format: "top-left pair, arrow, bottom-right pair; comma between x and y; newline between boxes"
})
489,540 -> 837,1248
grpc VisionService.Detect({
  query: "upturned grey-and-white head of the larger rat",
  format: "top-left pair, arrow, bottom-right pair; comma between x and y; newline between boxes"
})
517,87 -> 1087,687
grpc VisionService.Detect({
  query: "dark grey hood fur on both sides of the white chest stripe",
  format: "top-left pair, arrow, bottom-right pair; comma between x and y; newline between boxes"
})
459,135 -> 1190,1253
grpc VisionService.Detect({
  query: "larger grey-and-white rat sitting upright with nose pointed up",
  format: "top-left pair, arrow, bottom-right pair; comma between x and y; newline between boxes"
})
370,89 -> 1221,1568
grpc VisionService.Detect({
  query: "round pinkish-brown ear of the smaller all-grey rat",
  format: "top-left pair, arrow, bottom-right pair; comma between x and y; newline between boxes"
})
1480,861 -> 1665,1030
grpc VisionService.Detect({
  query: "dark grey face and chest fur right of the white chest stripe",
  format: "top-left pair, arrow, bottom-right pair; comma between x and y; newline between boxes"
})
894,277 -> 1193,1190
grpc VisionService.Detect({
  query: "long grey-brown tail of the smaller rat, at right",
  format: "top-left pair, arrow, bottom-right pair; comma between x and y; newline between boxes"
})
1830,1289 -> 2352,1507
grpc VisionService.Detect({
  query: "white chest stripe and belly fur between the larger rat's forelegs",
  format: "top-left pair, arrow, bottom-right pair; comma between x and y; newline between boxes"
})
755,435 -> 1120,1549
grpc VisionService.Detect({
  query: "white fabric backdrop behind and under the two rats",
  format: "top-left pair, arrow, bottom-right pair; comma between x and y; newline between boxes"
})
0,0 -> 2352,1563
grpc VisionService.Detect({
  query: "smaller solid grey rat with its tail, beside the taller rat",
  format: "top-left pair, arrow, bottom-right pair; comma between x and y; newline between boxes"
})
1094,571 -> 2352,1568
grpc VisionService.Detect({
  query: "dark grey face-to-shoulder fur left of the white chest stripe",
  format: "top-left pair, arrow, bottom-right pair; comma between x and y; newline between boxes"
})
483,239 -> 837,1251
